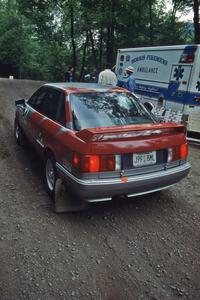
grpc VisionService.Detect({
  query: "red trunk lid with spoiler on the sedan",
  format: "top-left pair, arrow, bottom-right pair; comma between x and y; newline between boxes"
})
76,123 -> 186,154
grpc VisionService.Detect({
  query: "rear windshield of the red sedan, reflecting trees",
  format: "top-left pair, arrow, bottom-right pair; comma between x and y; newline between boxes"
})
70,92 -> 155,130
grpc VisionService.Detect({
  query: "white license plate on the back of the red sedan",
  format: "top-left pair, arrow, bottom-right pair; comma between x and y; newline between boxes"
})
133,151 -> 156,167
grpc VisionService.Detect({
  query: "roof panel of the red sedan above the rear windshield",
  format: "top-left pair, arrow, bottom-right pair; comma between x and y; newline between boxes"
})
45,82 -> 125,92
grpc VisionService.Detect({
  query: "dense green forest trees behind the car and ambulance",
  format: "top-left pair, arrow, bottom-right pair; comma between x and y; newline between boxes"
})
0,0 -> 195,81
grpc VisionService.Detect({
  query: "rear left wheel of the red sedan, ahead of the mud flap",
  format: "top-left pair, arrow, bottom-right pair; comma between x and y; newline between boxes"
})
44,152 -> 57,200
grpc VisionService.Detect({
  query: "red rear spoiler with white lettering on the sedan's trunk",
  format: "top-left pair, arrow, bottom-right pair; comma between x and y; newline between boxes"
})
76,123 -> 186,143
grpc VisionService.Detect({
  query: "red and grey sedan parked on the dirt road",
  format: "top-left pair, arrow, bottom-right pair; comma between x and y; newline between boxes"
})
15,83 -> 191,207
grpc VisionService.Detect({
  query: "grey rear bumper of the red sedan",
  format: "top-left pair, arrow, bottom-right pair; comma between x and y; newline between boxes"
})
56,162 -> 191,202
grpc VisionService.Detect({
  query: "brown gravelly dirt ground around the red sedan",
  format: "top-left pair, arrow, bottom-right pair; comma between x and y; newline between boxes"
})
0,79 -> 200,300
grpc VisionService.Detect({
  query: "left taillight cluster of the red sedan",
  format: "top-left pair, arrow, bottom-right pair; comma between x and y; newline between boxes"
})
72,152 -> 121,172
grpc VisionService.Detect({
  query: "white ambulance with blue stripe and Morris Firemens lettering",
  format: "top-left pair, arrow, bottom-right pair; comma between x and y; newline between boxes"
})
115,45 -> 200,132
